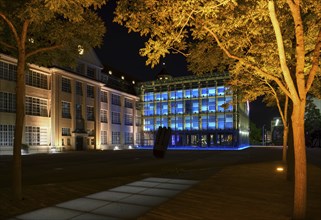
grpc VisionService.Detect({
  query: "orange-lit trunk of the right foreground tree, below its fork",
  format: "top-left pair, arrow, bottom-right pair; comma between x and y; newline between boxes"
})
292,102 -> 307,220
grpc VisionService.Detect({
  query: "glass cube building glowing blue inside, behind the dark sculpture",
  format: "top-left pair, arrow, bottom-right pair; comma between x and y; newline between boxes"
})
138,69 -> 249,148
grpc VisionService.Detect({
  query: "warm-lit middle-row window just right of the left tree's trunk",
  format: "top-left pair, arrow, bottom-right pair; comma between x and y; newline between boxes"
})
26,96 -> 48,117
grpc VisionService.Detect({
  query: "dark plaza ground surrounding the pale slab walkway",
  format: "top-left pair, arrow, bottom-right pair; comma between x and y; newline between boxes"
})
0,147 -> 321,219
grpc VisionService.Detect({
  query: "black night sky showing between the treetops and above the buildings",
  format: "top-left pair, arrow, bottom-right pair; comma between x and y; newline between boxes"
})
96,1 -> 279,128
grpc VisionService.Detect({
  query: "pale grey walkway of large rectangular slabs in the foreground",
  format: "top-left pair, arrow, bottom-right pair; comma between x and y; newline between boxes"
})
12,178 -> 197,220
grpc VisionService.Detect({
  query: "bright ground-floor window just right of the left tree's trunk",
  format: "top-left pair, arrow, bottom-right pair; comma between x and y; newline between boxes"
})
26,126 -> 47,146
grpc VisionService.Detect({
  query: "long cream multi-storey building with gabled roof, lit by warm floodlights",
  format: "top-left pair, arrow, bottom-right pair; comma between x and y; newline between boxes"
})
0,50 -> 141,155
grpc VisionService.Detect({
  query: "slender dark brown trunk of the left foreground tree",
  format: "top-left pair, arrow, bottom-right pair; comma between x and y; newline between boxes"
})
12,52 -> 26,200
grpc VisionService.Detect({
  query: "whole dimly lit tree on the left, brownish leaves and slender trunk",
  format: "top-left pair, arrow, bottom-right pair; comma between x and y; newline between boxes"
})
0,0 -> 105,200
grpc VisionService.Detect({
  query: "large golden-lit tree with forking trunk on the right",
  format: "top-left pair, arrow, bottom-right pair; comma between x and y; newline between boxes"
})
115,0 -> 321,219
